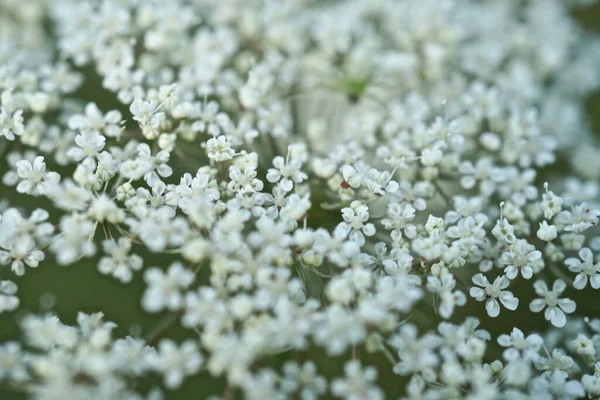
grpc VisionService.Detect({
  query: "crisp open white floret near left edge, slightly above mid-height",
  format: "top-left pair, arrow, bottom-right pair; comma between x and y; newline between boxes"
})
16,156 -> 60,196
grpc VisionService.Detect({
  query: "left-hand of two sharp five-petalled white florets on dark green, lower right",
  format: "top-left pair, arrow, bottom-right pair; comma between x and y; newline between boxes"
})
469,274 -> 519,318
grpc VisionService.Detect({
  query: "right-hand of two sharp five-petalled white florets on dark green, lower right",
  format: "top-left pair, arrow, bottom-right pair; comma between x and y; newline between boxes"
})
529,279 -> 575,328
